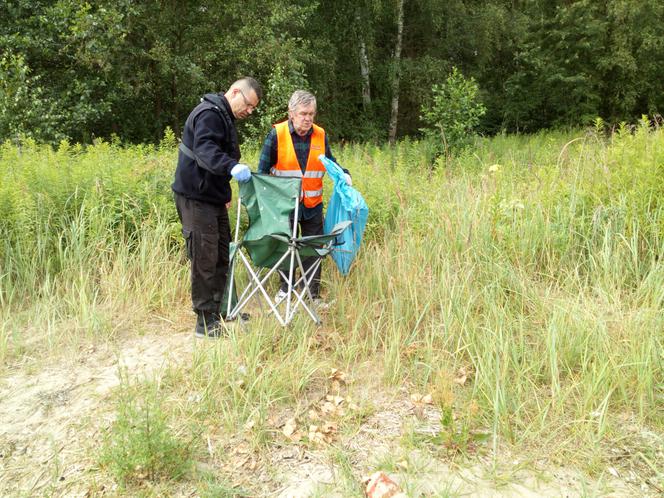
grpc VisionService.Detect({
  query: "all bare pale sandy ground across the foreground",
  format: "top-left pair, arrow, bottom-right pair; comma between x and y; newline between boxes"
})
0,320 -> 657,498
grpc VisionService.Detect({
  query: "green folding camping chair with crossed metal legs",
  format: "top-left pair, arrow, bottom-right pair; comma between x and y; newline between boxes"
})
226,174 -> 351,326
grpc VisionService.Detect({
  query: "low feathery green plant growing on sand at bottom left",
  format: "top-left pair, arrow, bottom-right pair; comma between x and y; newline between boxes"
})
99,386 -> 192,487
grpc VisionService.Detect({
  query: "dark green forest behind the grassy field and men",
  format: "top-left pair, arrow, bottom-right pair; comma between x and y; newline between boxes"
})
0,0 -> 664,143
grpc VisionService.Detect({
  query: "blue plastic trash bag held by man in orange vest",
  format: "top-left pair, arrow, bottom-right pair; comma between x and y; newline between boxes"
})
318,154 -> 369,275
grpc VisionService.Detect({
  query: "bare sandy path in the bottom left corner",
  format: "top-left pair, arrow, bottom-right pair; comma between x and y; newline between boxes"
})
0,326 -> 193,496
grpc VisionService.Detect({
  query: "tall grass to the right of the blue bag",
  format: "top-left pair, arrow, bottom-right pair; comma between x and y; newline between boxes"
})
335,126 -> 664,466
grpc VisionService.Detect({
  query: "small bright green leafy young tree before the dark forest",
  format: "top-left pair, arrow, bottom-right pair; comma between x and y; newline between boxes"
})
421,68 -> 486,153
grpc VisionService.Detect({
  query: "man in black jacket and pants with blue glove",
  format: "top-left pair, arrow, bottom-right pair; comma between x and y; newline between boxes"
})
172,77 -> 263,337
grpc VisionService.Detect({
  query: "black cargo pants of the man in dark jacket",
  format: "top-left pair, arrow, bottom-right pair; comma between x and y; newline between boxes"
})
174,194 -> 231,316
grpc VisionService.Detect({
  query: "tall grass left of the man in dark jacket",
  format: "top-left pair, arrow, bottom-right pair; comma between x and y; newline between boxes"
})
0,136 -> 186,364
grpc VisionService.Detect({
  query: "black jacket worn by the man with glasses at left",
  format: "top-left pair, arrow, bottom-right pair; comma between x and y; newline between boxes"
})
172,93 -> 240,205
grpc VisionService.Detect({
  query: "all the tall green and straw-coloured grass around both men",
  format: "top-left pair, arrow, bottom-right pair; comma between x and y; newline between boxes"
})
0,126 -> 664,489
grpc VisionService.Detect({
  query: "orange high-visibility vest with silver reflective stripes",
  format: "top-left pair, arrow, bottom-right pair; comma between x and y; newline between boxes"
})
270,121 -> 325,208
